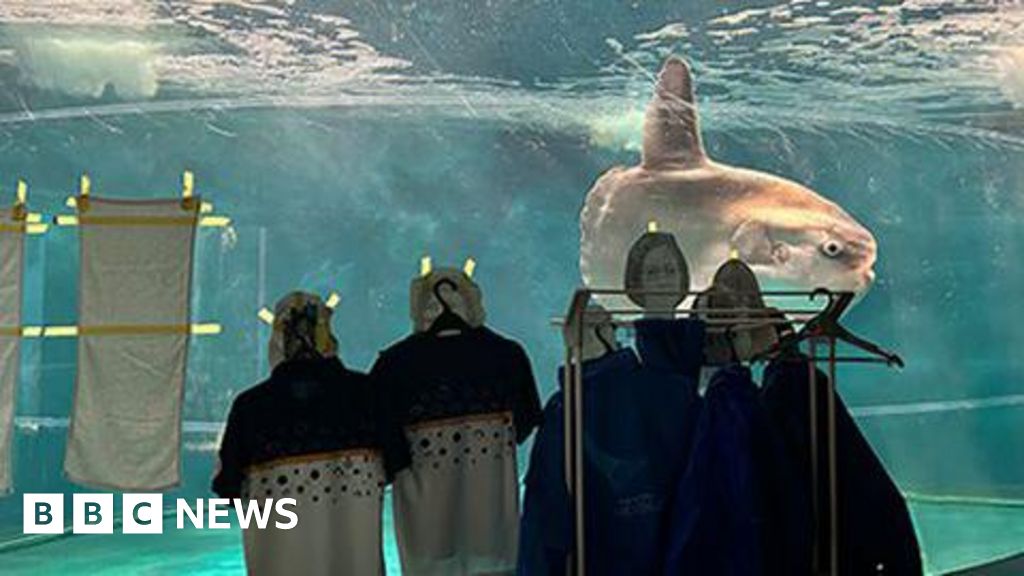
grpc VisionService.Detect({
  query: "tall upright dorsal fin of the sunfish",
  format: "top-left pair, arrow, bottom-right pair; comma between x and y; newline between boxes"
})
643,56 -> 705,168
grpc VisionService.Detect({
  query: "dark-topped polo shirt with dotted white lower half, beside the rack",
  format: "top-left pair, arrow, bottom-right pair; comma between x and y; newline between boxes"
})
373,327 -> 541,576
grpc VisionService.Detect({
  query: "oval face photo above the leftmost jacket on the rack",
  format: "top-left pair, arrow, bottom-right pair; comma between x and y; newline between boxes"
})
625,232 -> 689,311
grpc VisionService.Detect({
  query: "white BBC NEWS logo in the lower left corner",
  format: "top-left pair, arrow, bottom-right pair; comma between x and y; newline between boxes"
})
22,494 -> 299,534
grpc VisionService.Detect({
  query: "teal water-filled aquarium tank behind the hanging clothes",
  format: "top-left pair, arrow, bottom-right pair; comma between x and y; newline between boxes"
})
0,0 -> 1024,575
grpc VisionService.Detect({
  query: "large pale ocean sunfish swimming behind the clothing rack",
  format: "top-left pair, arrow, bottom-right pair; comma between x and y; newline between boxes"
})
580,57 -> 877,303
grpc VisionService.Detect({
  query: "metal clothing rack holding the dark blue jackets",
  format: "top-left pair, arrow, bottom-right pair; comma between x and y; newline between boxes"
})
559,288 -> 902,576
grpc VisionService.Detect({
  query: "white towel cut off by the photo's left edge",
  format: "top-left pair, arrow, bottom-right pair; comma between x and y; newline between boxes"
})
0,212 -> 25,493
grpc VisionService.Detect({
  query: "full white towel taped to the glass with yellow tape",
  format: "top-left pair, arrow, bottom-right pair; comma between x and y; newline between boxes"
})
65,198 -> 199,491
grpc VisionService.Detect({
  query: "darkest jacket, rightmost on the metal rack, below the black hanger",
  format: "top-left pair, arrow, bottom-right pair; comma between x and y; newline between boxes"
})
762,357 -> 922,576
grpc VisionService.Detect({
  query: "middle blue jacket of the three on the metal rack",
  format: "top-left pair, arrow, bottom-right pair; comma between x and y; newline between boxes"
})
663,365 -> 810,576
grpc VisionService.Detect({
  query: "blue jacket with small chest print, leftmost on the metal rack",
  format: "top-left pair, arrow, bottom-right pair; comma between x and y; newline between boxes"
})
518,321 -> 703,576
